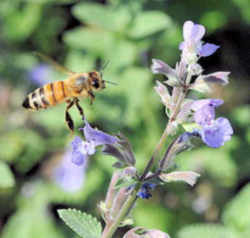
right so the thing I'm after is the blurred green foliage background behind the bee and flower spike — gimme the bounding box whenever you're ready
[0,0,250,238]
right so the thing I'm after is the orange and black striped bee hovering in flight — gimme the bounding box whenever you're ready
[22,53,112,132]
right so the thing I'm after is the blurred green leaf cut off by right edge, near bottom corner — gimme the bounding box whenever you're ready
[222,184,250,231]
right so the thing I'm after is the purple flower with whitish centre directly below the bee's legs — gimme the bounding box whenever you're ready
[72,120,118,165]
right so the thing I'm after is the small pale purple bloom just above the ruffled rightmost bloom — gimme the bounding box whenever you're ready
[191,99,223,126]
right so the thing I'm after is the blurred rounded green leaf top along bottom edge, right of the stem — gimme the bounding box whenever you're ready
[177,224,237,238]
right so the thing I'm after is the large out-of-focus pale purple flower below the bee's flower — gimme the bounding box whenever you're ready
[52,150,87,192]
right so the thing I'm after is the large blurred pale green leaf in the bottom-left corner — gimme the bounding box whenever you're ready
[1,187,64,238]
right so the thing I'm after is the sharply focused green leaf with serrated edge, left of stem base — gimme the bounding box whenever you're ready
[58,209,102,238]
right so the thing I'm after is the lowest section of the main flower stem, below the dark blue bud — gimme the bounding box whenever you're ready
[101,184,140,238]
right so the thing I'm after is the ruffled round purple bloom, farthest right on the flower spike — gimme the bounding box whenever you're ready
[200,117,233,148]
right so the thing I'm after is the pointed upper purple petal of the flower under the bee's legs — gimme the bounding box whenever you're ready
[80,120,118,146]
